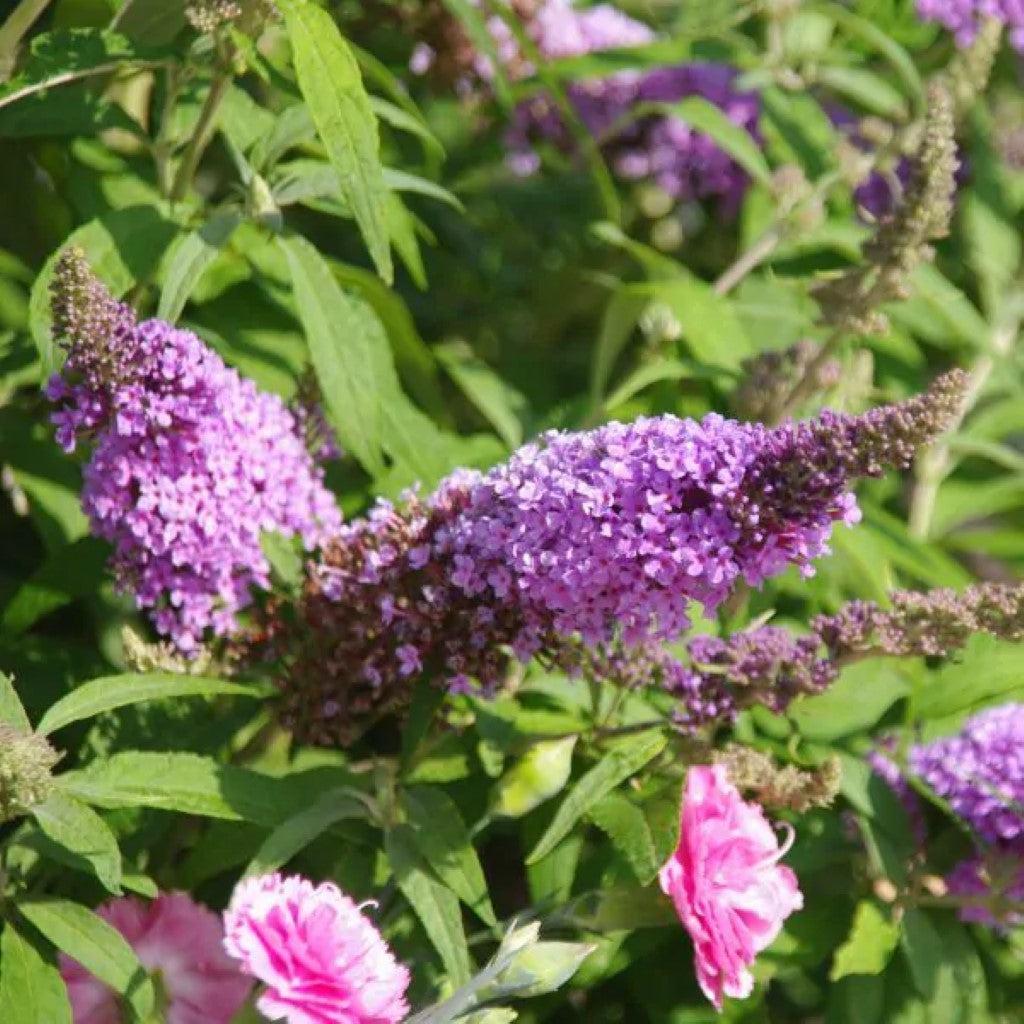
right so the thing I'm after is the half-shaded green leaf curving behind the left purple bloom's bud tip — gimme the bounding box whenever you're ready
[29,206,176,371]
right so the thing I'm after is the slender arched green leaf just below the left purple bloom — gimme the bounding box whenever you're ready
[38,672,262,736]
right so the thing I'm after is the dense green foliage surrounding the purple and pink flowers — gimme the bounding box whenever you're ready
[0,0,1024,1024]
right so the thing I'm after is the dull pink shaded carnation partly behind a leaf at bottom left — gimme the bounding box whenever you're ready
[60,893,252,1024]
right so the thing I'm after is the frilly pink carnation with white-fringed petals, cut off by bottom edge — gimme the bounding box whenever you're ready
[224,874,409,1024]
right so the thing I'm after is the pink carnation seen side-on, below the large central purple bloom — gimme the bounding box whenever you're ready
[658,765,804,1010]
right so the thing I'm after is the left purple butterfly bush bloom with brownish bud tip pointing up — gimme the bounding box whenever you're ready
[47,250,341,651]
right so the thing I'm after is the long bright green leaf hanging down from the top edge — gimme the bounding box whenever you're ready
[285,0,392,282]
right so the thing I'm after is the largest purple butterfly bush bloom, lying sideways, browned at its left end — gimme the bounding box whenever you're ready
[284,372,964,741]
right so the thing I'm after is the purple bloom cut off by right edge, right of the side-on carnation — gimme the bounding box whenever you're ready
[908,703,1024,851]
